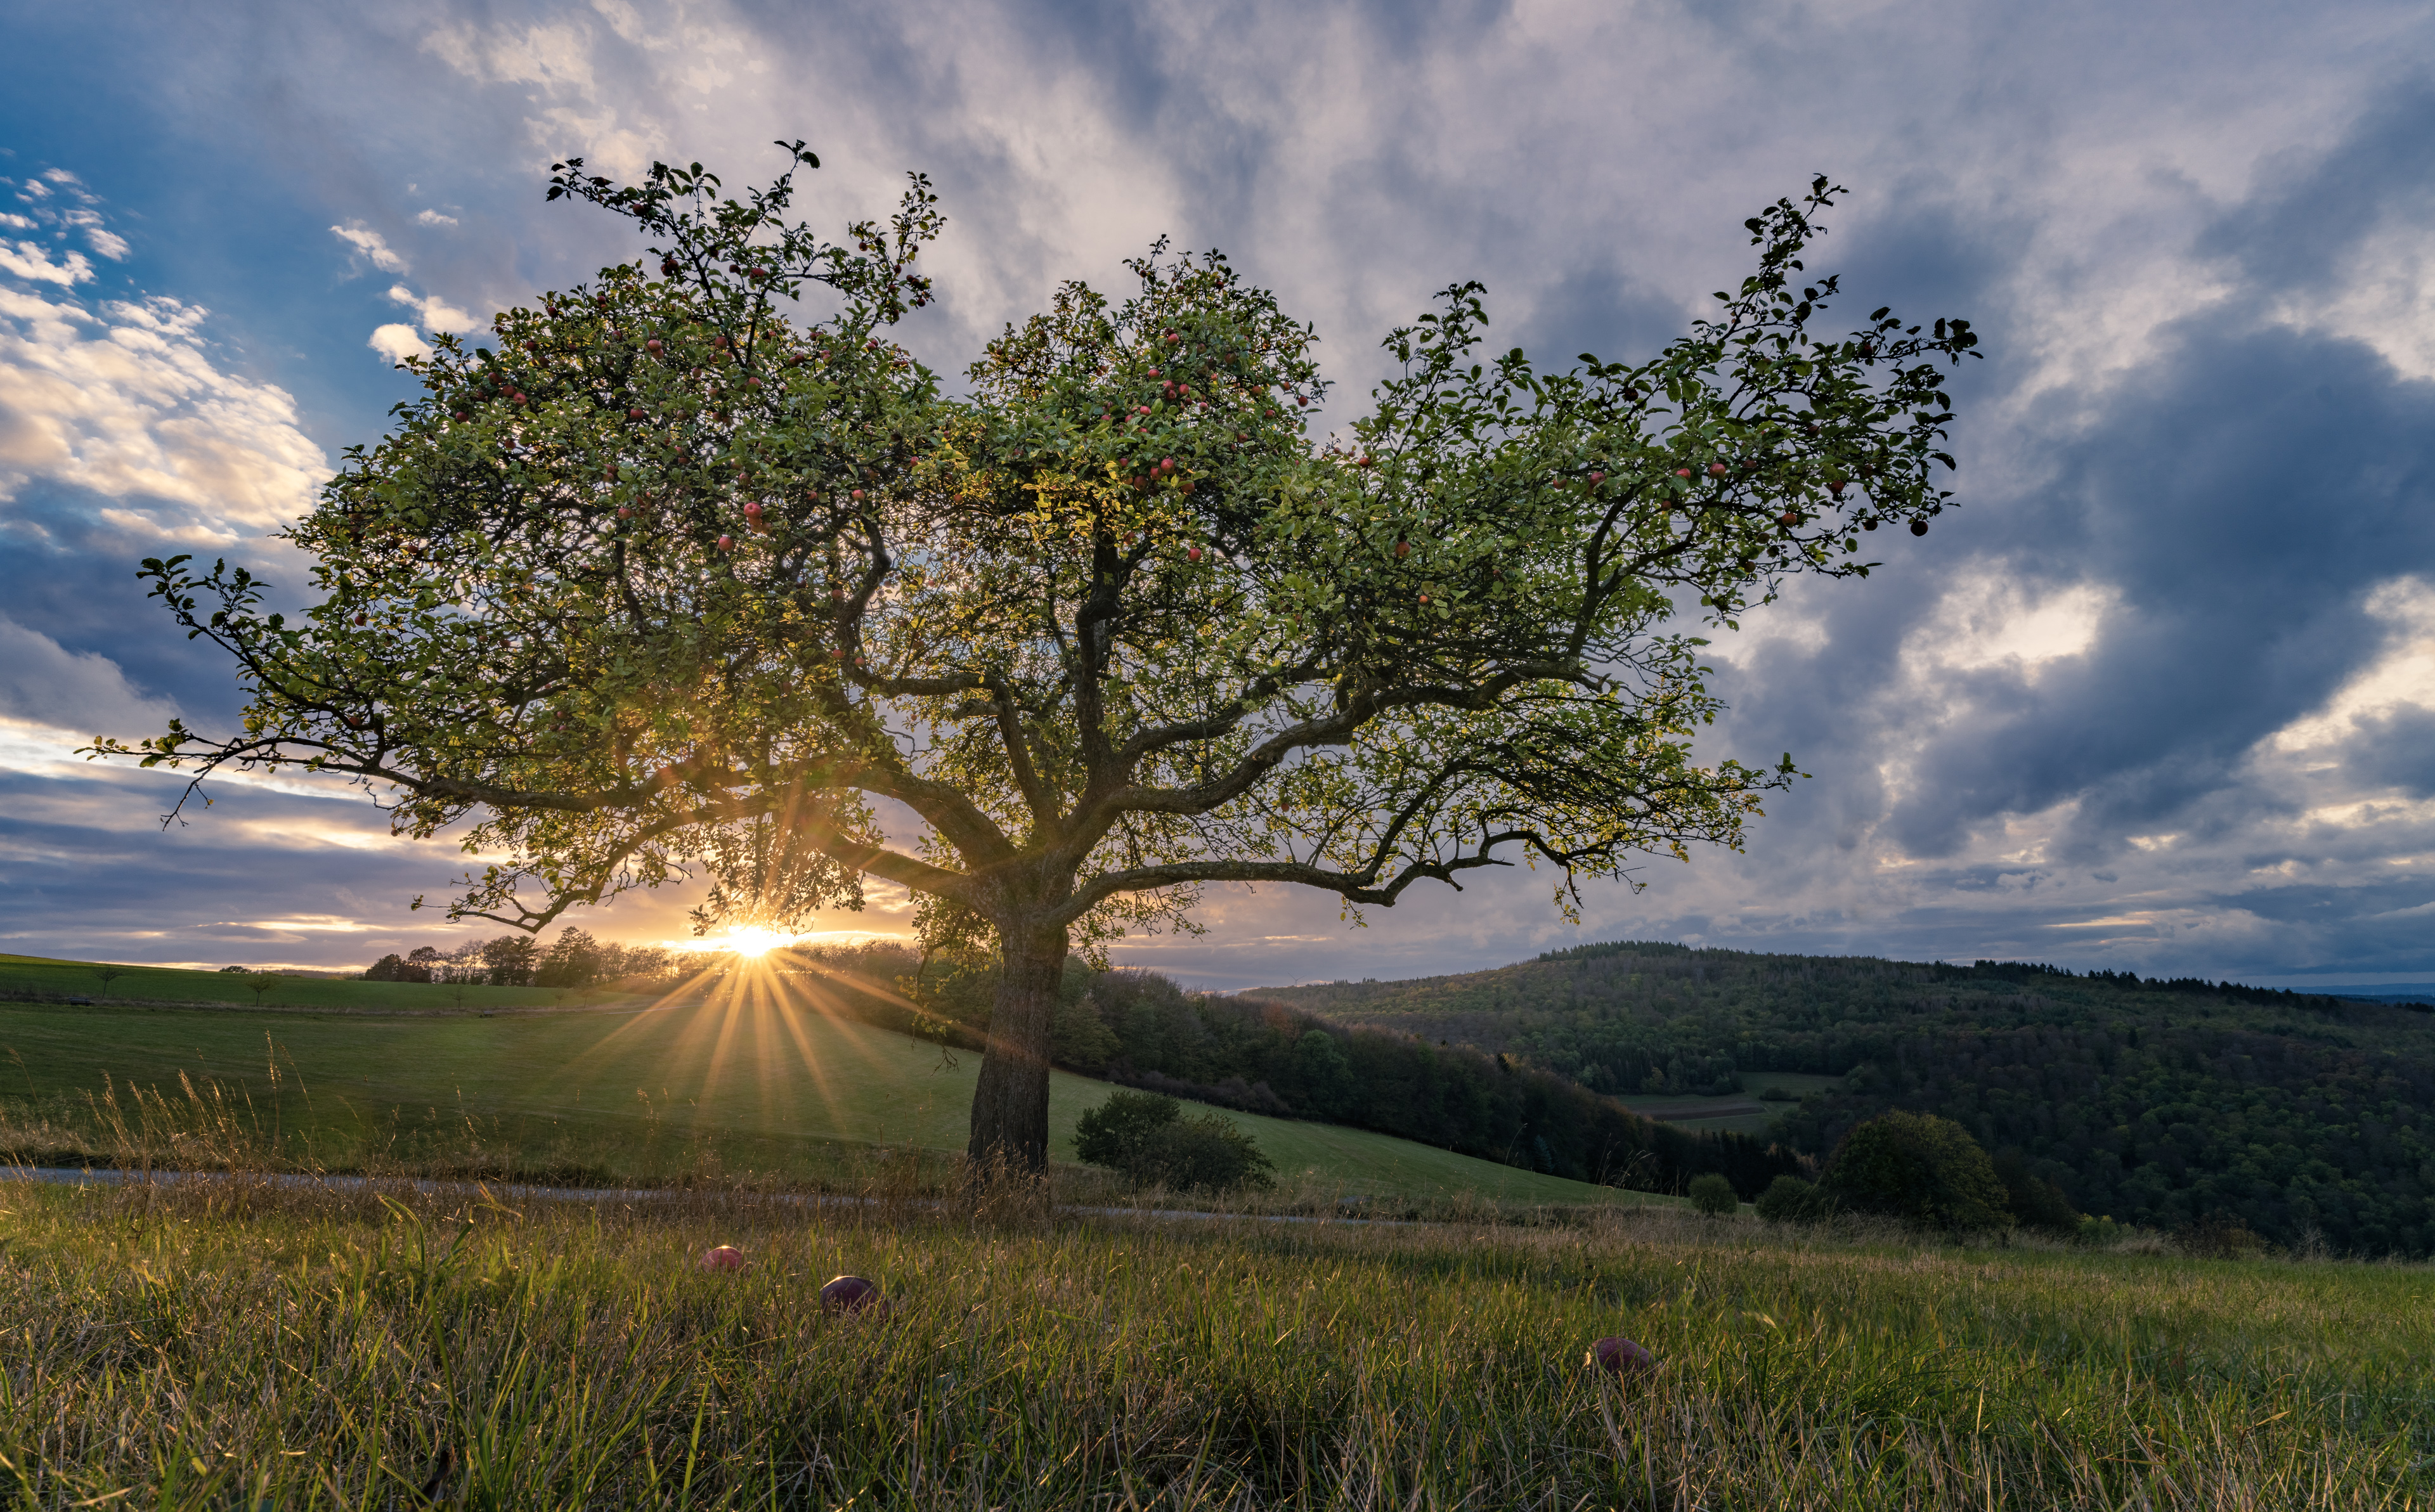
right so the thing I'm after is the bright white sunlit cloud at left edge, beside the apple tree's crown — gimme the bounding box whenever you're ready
[0,287,328,545]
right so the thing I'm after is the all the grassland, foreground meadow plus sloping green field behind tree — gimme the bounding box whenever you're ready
[0,964,2435,1512]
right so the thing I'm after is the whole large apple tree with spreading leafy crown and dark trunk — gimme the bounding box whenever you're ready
[98,144,1975,1168]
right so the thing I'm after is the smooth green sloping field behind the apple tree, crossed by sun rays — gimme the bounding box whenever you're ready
[0,976,1644,1203]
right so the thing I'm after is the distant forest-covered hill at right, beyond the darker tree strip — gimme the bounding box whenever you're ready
[1237,942,2435,1257]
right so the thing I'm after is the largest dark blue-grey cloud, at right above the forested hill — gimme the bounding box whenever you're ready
[1897,316,2435,860]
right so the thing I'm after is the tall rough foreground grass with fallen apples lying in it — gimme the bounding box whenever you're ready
[0,1186,2435,1512]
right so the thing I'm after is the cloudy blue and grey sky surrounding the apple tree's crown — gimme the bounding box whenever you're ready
[0,0,2435,988]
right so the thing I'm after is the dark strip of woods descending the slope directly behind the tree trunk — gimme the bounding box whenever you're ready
[772,947,1804,1198]
